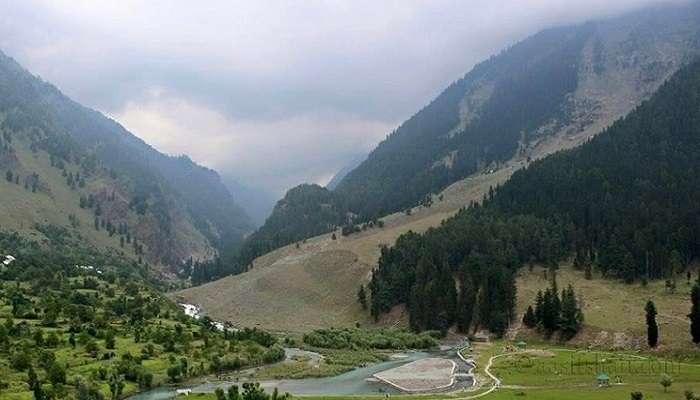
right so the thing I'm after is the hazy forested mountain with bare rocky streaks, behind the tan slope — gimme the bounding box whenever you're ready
[231,2,700,272]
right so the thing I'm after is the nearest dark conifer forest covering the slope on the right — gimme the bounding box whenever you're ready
[370,57,700,333]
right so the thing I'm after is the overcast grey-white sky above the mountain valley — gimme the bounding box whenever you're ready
[0,0,684,195]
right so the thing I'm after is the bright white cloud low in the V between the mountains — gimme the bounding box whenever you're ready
[112,91,396,196]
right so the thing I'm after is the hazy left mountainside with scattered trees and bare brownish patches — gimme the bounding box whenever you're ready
[0,53,252,267]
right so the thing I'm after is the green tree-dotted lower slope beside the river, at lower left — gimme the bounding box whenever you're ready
[0,231,284,399]
